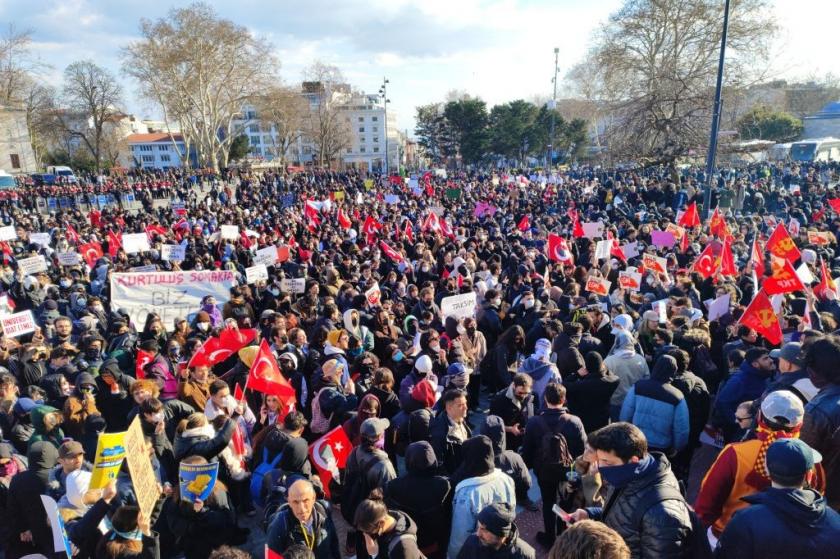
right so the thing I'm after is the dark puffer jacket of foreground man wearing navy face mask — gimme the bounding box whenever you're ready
[587,452,691,559]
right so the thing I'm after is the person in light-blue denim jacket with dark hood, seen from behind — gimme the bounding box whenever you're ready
[448,436,516,558]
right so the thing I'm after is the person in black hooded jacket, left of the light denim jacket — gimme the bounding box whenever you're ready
[384,441,452,557]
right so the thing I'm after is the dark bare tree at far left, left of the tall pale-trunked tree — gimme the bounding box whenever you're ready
[57,60,122,170]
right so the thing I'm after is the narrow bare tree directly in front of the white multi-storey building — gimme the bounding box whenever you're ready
[303,61,351,166]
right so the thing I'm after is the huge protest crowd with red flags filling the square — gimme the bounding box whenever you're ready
[0,162,840,559]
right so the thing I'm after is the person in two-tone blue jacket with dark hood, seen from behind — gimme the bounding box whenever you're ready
[620,355,691,451]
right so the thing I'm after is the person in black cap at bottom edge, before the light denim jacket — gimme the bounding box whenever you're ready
[458,503,536,559]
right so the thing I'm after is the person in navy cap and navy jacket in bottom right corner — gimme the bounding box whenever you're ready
[715,439,840,559]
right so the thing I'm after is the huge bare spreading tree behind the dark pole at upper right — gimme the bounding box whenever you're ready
[570,0,776,164]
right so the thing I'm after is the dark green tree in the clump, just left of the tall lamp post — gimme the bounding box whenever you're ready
[489,99,539,162]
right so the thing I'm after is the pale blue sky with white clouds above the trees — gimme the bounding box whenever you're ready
[6,0,840,133]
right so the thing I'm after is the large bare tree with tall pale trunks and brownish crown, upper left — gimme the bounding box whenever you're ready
[123,3,279,169]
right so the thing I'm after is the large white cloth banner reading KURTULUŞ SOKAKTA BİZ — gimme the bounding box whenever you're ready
[111,270,236,330]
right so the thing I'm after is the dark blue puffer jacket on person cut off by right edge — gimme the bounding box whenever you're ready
[800,384,840,510]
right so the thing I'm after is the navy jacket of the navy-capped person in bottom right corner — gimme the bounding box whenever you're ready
[715,487,840,559]
